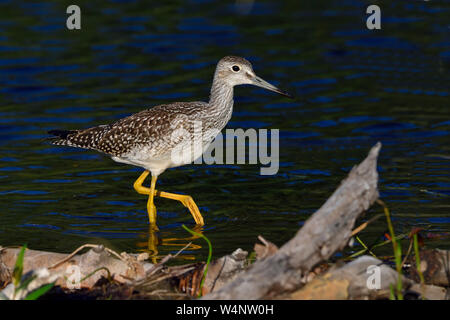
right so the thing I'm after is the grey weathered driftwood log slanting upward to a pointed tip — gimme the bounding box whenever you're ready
[204,143,381,299]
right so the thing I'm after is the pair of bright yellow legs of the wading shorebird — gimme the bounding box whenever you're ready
[133,170,205,225]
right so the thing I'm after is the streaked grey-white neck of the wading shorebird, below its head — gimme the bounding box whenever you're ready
[208,74,233,127]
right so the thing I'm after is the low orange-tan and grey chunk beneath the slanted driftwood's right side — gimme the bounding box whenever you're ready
[285,256,412,300]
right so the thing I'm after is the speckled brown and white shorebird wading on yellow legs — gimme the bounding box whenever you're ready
[48,56,291,226]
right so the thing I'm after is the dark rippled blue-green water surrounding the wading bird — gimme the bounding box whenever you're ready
[0,1,450,260]
